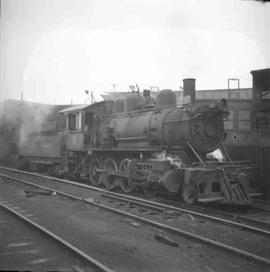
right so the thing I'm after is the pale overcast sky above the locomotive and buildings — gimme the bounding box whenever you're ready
[0,0,270,104]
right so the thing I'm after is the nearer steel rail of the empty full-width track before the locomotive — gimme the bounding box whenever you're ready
[1,174,270,266]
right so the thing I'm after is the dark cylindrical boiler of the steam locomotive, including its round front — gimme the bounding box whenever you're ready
[110,93,225,153]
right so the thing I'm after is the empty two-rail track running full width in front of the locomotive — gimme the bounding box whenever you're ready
[0,167,270,266]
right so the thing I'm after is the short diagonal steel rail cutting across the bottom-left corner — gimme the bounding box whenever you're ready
[0,202,113,272]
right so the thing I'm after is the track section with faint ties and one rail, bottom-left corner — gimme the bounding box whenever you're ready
[0,199,112,272]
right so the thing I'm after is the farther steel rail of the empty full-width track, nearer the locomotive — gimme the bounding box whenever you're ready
[0,166,270,236]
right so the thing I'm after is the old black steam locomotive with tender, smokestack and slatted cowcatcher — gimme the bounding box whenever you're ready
[19,79,256,204]
